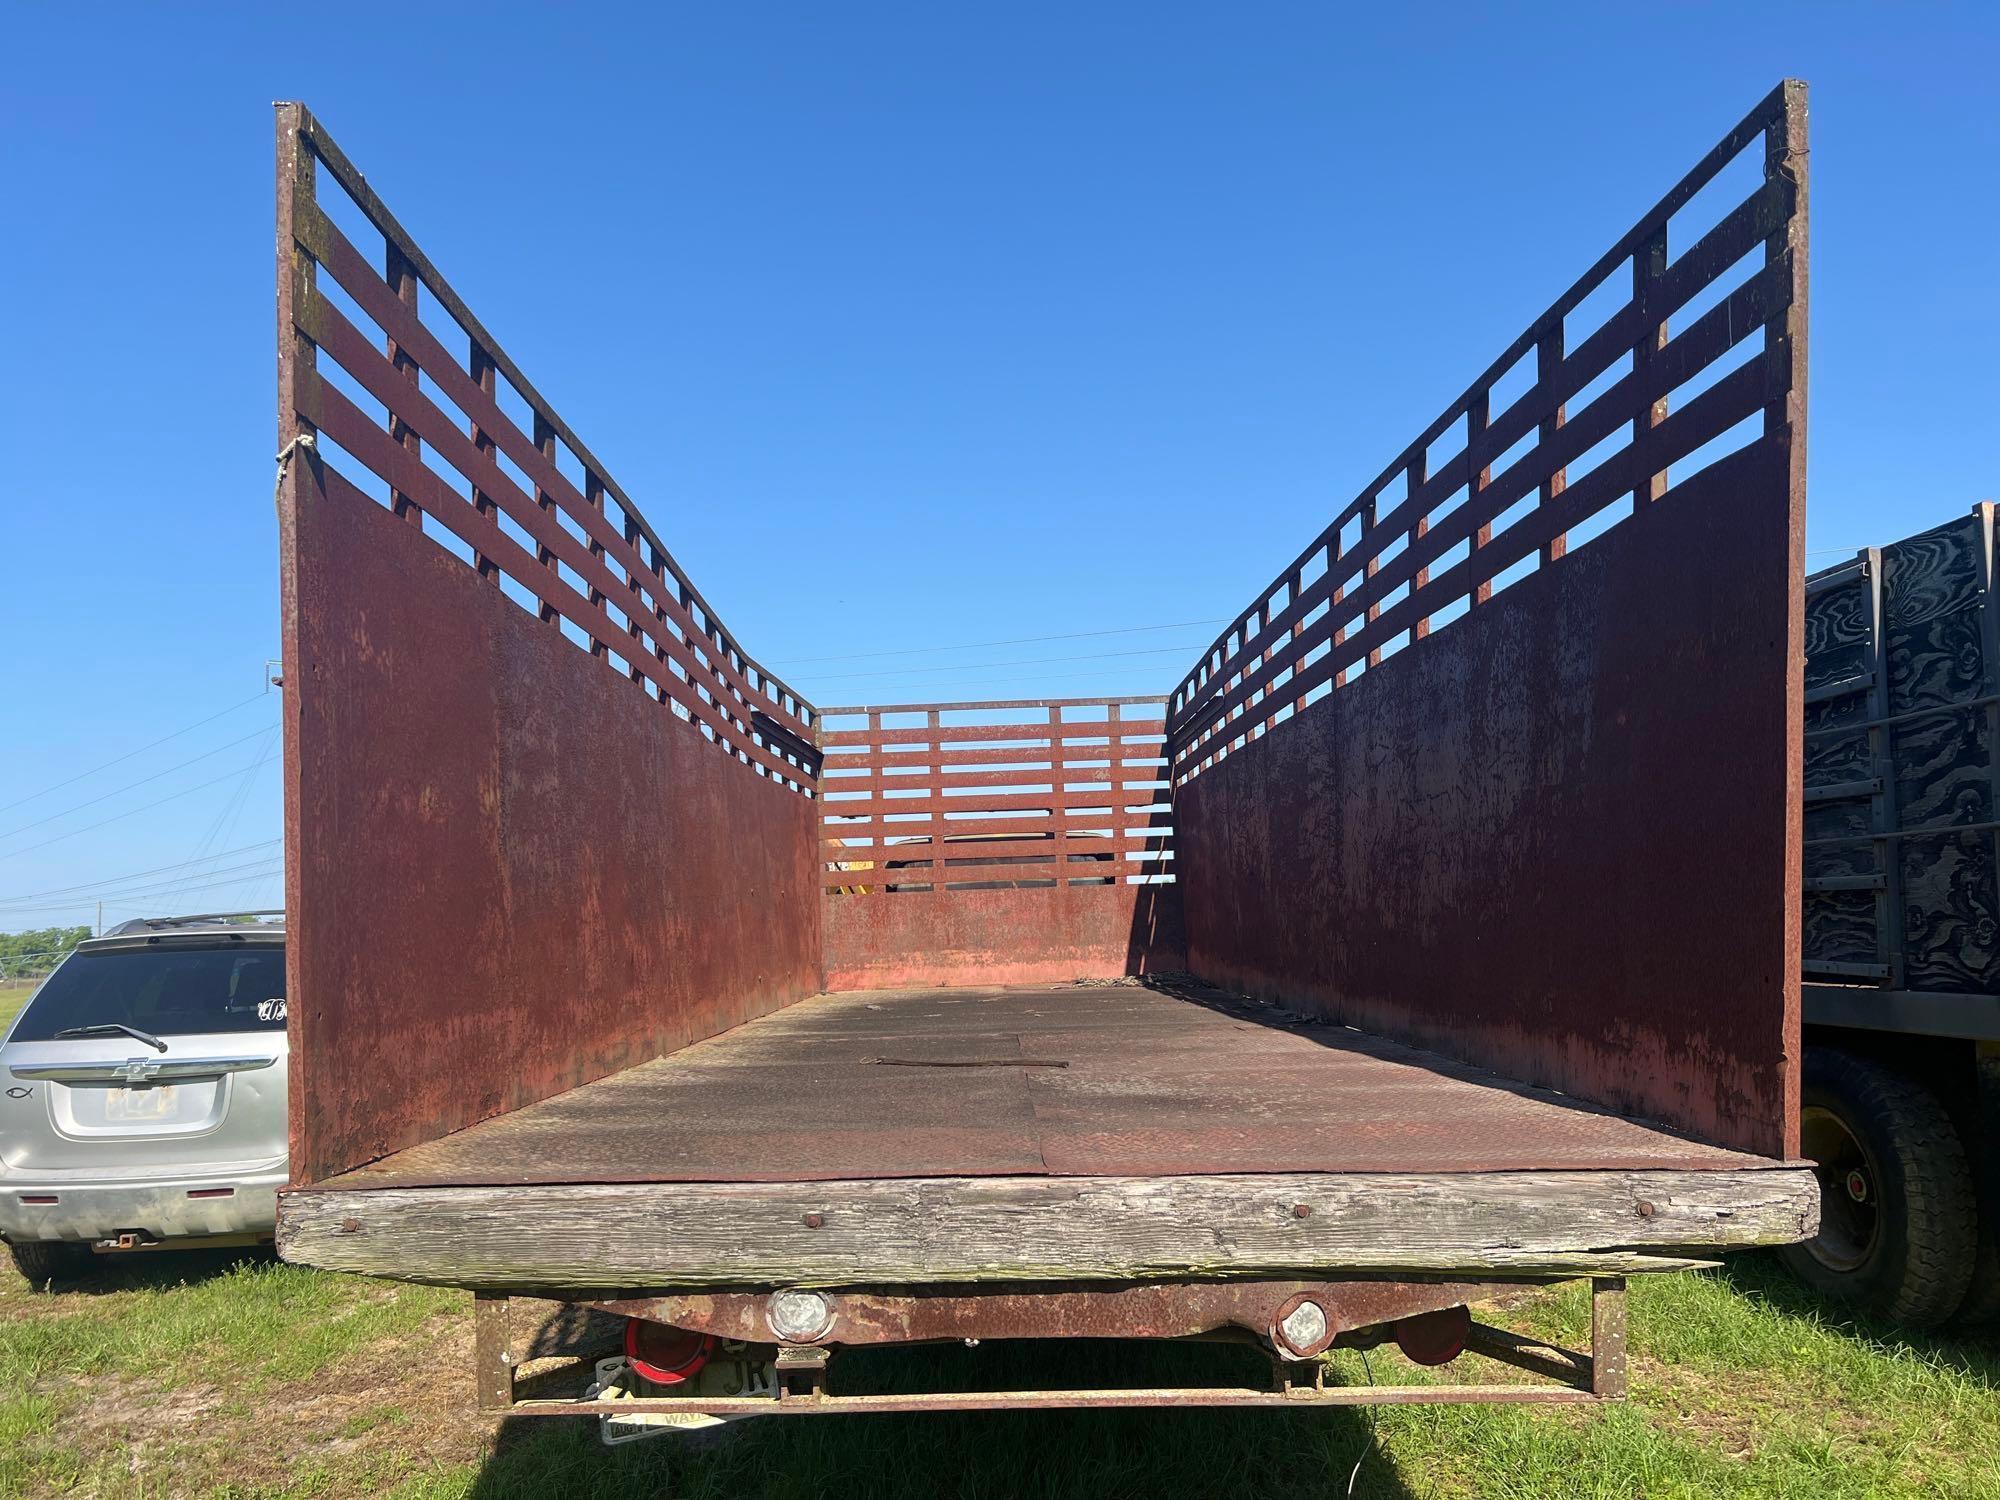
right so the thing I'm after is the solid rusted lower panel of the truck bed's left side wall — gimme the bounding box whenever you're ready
[286,474,820,1182]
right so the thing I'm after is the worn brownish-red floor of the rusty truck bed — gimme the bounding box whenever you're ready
[320,984,1772,1190]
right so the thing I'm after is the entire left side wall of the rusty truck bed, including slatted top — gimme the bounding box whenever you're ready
[278,104,820,1182]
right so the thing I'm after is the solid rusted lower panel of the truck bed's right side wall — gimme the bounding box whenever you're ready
[1174,442,1798,1156]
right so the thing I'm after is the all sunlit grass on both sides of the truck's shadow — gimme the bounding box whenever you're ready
[0,1256,2000,1500]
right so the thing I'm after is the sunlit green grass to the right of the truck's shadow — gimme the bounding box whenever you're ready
[1340,1256,2000,1500]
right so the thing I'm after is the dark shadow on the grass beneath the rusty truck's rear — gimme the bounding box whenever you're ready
[472,1344,1412,1500]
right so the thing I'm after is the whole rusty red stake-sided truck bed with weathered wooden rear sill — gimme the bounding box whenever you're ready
[278,82,1818,1424]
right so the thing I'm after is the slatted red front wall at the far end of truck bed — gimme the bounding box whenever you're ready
[820,698,1186,990]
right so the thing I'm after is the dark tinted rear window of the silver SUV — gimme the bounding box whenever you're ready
[12,944,284,1042]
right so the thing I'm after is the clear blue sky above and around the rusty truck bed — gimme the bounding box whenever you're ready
[0,4,2000,930]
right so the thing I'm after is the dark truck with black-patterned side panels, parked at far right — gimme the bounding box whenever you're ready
[1786,504,2000,1326]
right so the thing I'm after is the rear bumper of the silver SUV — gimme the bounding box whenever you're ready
[0,1168,286,1244]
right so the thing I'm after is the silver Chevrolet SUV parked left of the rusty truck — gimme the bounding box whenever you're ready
[0,918,286,1284]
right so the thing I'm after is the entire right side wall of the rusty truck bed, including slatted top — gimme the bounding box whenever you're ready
[1168,84,1806,1156]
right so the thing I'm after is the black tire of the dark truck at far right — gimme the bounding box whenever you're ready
[1780,1046,1978,1328]
